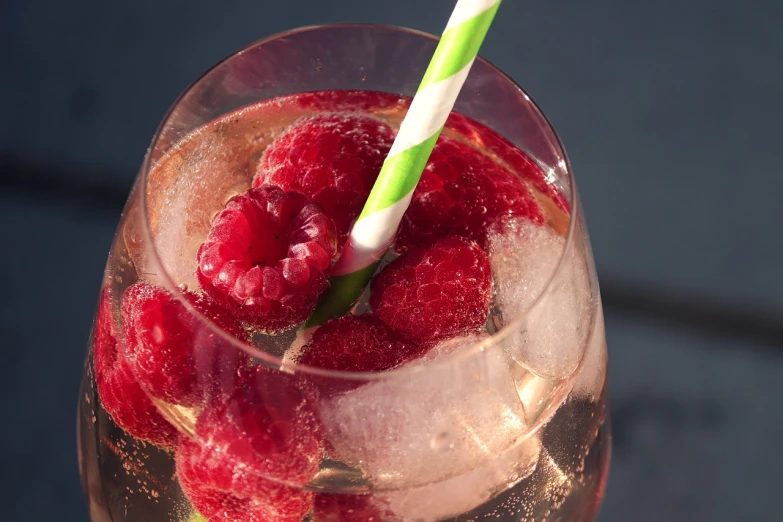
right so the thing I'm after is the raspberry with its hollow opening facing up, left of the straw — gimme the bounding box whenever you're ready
[197,186,337,332]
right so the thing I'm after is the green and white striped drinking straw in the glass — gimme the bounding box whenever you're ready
[305,0,501,328]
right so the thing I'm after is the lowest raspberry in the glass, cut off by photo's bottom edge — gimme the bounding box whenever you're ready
[176,437,313,522]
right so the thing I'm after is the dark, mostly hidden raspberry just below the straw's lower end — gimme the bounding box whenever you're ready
[299,314,422,372]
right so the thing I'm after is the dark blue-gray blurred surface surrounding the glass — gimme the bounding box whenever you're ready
[0,0,783,522]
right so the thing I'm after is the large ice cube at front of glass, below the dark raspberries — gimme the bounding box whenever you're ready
[321,335,528,489]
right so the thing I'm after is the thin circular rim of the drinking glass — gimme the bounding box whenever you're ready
[139,23,580,382]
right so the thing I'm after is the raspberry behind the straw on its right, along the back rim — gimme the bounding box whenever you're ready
[395,137,544,252]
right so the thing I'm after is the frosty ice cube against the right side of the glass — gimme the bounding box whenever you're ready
[490,221,593,379]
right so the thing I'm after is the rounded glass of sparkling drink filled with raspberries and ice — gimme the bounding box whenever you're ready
[78,26,610,521]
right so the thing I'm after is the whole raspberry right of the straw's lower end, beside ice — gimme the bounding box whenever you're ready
[370,236,492,343]
